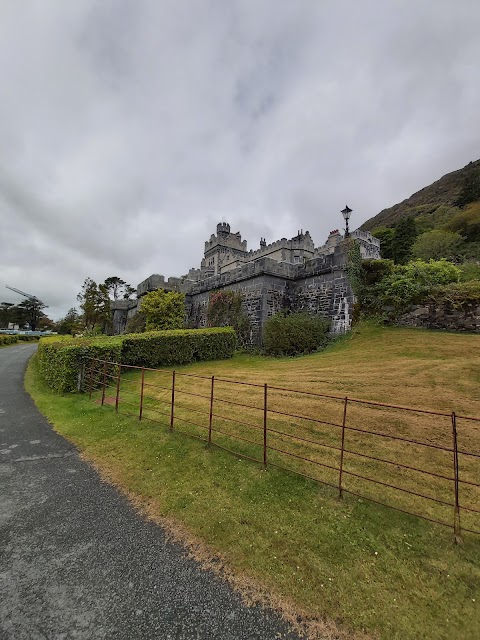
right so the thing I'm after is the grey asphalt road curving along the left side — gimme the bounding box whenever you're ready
[0,345,298,640]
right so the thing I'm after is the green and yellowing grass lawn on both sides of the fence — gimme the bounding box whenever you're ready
[26,325,480,640]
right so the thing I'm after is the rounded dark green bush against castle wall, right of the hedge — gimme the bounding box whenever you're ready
[263,313,330,356]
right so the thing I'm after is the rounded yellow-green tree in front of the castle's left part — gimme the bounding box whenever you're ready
[140,289,185,331]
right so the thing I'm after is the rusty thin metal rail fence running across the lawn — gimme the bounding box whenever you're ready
[83,359,480,541]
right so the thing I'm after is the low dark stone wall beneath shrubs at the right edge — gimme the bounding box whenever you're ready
[395,302,480,333]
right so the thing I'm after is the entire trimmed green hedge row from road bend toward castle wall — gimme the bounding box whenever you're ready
[38,327,236,393]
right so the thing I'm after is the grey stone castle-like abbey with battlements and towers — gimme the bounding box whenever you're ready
[113,222,380,344]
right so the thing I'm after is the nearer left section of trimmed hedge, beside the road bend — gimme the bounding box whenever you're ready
[37,338,122,393]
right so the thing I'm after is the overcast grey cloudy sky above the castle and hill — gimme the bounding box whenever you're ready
[0,0,480,319]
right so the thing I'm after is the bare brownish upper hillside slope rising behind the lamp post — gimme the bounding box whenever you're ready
[360,160,480,231]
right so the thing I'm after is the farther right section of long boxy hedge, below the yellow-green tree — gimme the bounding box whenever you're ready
[122,327,236,368]
